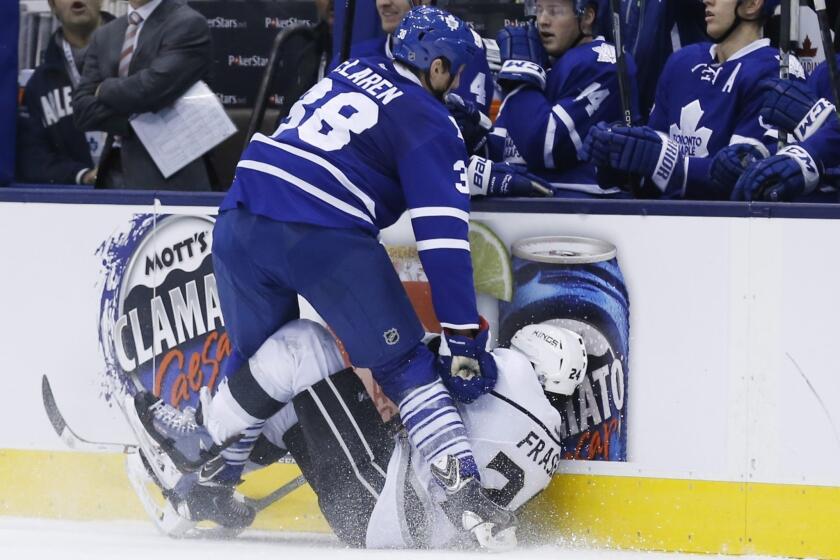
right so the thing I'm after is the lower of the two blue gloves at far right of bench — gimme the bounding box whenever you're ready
[732,145,822,202]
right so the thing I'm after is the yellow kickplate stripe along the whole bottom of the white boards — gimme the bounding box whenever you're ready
[0,450,840,560]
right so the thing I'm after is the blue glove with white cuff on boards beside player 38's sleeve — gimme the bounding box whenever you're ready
[467,156,553,196]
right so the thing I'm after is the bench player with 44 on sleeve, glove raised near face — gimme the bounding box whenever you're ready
[488,0,637,197]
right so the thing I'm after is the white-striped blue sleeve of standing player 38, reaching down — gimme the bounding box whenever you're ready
[397,116,478,329]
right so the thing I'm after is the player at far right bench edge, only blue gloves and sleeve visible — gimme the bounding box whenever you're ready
[728,75,840,202]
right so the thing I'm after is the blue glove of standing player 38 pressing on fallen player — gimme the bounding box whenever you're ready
[437,317,498,403]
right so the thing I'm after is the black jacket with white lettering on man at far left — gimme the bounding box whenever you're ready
[17,12,114,184]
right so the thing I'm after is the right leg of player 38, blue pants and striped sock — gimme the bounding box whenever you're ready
[288,224,516,546]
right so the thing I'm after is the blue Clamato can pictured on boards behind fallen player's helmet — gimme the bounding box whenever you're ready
[499,237,630,461]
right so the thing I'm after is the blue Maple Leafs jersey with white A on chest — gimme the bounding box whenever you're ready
[648,39,805,200]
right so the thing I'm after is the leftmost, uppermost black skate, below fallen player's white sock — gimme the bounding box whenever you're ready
[125,391,222,472]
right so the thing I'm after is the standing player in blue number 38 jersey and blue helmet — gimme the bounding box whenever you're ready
[125,7,515,548]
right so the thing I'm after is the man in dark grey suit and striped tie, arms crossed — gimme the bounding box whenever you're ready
[73,0,212,190]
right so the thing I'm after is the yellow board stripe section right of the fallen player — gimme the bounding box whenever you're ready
[523,475,840,559]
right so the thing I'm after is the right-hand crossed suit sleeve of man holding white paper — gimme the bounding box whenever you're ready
[96,12,212,115]
